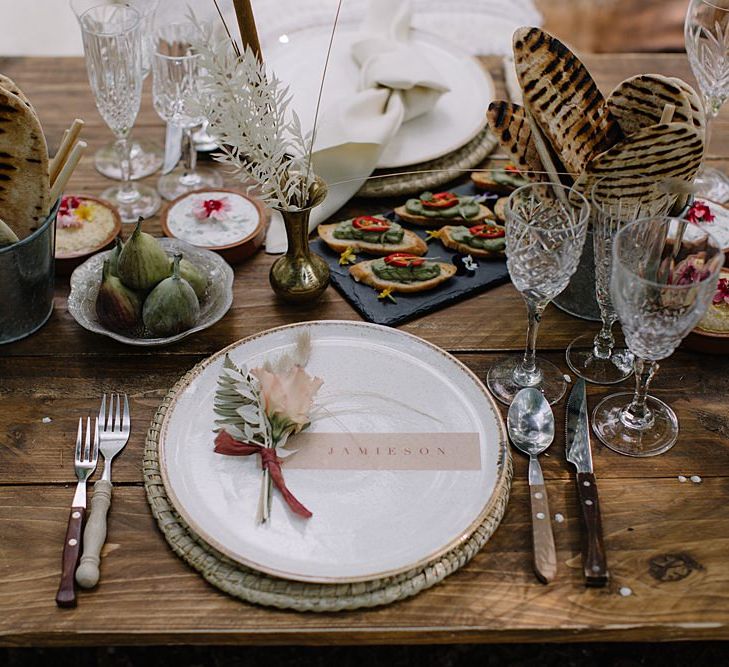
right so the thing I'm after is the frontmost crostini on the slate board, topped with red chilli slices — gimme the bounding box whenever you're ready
[349,252,456,292]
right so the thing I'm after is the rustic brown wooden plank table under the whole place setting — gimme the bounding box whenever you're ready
[0,55,729,646]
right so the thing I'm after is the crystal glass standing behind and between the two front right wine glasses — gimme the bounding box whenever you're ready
[566,178,676,384]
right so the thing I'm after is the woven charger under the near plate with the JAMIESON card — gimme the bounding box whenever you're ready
[143,369,512,612]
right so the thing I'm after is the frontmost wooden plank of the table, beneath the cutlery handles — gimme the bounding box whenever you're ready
[0,478,729,644]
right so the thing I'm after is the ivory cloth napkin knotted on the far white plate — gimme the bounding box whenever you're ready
[266,0,448,253]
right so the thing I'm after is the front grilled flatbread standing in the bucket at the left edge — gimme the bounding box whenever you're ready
[0,85,49,239]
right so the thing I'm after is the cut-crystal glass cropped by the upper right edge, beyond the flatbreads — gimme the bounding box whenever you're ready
[684,0,729,202]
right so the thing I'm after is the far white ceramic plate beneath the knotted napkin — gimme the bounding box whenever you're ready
[265,26,495,168]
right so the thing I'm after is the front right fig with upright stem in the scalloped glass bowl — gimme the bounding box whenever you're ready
[142,254,200,337]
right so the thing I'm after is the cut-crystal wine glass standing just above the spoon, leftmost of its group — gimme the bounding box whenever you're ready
[486,183,590,404]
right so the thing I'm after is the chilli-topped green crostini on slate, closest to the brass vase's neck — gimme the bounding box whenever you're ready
[318,215,428,255]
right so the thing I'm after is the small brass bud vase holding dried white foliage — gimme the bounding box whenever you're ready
[268,178,329,303]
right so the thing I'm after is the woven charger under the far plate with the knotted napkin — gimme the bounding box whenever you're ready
[357,127,498,197]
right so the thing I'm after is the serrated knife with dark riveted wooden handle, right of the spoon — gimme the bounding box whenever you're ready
[565,378,610,587]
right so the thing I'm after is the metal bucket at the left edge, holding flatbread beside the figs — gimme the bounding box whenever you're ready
[0,199,60,344]
